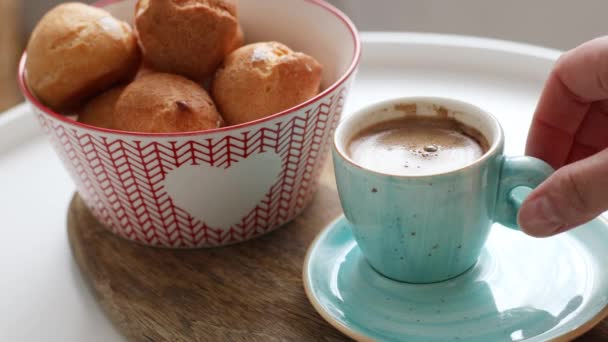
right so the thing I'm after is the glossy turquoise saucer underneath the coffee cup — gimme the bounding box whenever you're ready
[304,217,608,342]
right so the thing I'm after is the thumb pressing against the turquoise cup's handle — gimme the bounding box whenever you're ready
[518,149,608,237]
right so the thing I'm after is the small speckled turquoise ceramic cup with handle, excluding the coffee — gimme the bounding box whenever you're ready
[333,97,553,283]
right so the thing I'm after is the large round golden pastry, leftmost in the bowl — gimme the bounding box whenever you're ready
[26,3,140,110]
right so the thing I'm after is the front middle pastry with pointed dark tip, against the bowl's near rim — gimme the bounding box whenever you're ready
[114,73,223,133]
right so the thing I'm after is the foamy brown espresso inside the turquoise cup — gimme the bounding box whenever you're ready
[347,116,489,176]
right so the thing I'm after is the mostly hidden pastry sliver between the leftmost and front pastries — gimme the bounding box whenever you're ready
[78,85,125,129]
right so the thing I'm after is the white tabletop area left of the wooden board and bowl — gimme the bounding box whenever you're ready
[0,104,123,342]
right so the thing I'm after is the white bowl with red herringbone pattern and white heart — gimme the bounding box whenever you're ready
[19,0,361,248]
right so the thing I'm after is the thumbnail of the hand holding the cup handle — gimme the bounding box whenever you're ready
[517,196,562,237]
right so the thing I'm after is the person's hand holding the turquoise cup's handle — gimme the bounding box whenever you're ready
[518,37,608,237]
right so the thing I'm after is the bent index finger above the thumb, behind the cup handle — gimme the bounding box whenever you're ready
[526,37,608,168]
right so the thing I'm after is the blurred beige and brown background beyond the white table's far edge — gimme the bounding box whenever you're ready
[0,0,608,112]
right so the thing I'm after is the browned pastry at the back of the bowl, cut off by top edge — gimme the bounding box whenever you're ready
[135,0,239,81]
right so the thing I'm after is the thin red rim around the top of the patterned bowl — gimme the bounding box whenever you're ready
[18,0,361,137]
